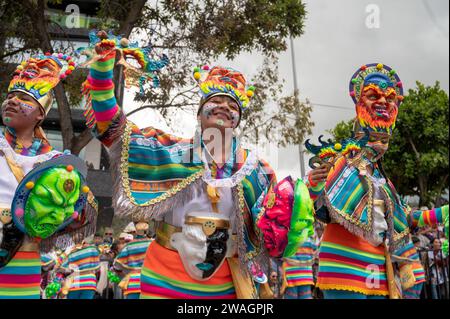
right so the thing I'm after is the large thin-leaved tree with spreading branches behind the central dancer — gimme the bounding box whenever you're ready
[0,0,313,153]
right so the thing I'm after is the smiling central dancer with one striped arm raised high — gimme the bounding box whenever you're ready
[80,32,312,299]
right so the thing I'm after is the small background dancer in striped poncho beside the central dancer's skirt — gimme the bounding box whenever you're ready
[113,221,152,299]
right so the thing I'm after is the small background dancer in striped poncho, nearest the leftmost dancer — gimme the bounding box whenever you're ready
[61,238,100,299]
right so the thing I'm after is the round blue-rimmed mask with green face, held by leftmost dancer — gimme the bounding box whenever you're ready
[11,155,89,239]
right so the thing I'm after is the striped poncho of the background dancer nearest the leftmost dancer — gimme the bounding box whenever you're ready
[61,246,100,291]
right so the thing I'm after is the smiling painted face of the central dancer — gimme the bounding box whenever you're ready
[200,96,240,129]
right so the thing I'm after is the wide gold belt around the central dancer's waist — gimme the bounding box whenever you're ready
[155,220,236,251]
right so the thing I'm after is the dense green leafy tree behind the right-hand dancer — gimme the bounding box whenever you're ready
[330,82,449,207]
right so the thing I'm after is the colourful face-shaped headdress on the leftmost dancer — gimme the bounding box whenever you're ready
[8,53,75,115]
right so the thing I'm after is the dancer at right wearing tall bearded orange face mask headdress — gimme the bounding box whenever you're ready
[306,64,448,299]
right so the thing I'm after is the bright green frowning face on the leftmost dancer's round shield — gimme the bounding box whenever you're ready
[24,168,81,238]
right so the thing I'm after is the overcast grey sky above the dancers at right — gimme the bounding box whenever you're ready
[127,0,449,178]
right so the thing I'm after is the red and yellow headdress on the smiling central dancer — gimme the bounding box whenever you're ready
[194,66,255,112]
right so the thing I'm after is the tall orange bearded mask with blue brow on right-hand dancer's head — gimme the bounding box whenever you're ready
[350,63,403,135]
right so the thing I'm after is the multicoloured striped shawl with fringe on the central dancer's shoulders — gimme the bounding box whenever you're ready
[110,122,275,272]
